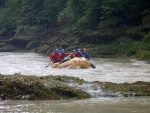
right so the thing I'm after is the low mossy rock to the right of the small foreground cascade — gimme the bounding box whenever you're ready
[95,81,150,97]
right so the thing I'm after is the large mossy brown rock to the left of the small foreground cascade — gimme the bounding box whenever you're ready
[0,75,90,100]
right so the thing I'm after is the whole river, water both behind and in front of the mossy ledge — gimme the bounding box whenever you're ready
[0,52,150,113]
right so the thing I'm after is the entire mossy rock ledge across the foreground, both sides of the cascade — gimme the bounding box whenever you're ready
[0,73,150,100]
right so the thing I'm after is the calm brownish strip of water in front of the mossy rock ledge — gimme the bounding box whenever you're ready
[0,97,150,113]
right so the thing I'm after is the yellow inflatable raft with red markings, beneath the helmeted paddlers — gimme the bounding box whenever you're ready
[51,57,90,69]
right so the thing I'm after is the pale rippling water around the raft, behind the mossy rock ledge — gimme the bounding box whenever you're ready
[0,52,150,83]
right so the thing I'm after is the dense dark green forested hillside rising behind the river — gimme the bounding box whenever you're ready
[0,0,150,59]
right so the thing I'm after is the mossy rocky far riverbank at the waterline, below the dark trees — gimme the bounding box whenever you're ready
[0,37,150,62]
